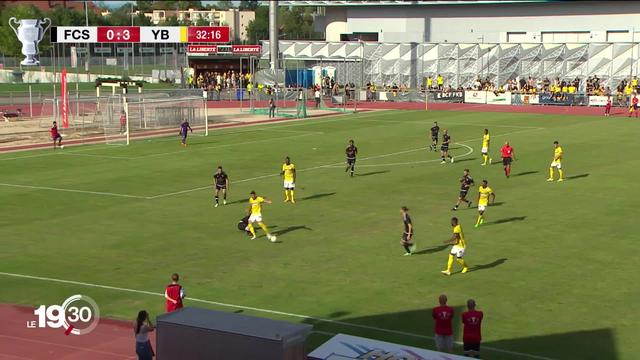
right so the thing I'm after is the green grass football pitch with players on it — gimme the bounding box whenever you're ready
[0,111,640,360]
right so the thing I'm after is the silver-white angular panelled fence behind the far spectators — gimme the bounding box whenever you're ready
[262,41,640,91]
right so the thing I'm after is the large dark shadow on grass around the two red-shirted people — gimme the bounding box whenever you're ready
[303,310,620,360]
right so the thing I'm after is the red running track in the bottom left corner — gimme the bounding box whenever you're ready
[0,304,146,360]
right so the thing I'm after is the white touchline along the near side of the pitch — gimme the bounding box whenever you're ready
[0,271,553,360]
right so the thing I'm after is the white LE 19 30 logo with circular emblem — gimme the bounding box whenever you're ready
[27,295,100,335]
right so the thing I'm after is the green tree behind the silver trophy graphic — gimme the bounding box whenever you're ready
[0,5,43,57]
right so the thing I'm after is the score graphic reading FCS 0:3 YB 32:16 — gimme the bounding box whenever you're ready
[50,26,231,44]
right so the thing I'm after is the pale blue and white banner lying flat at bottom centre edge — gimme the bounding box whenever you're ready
[307,334,468,360]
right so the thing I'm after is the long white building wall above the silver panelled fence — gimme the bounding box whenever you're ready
[325,1,640,43]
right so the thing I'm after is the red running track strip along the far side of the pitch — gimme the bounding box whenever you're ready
[0,101,627,152]
